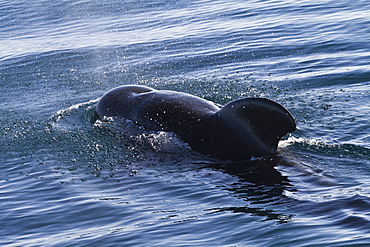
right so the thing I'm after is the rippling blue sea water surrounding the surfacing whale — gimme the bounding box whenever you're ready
[0,0,370,246]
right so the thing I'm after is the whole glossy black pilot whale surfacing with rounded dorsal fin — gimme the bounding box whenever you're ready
[95,85,296,161]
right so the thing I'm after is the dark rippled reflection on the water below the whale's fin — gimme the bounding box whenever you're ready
[202,156,296,224]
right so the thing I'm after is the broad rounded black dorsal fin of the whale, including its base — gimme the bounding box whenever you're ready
[212,98,296,160]
